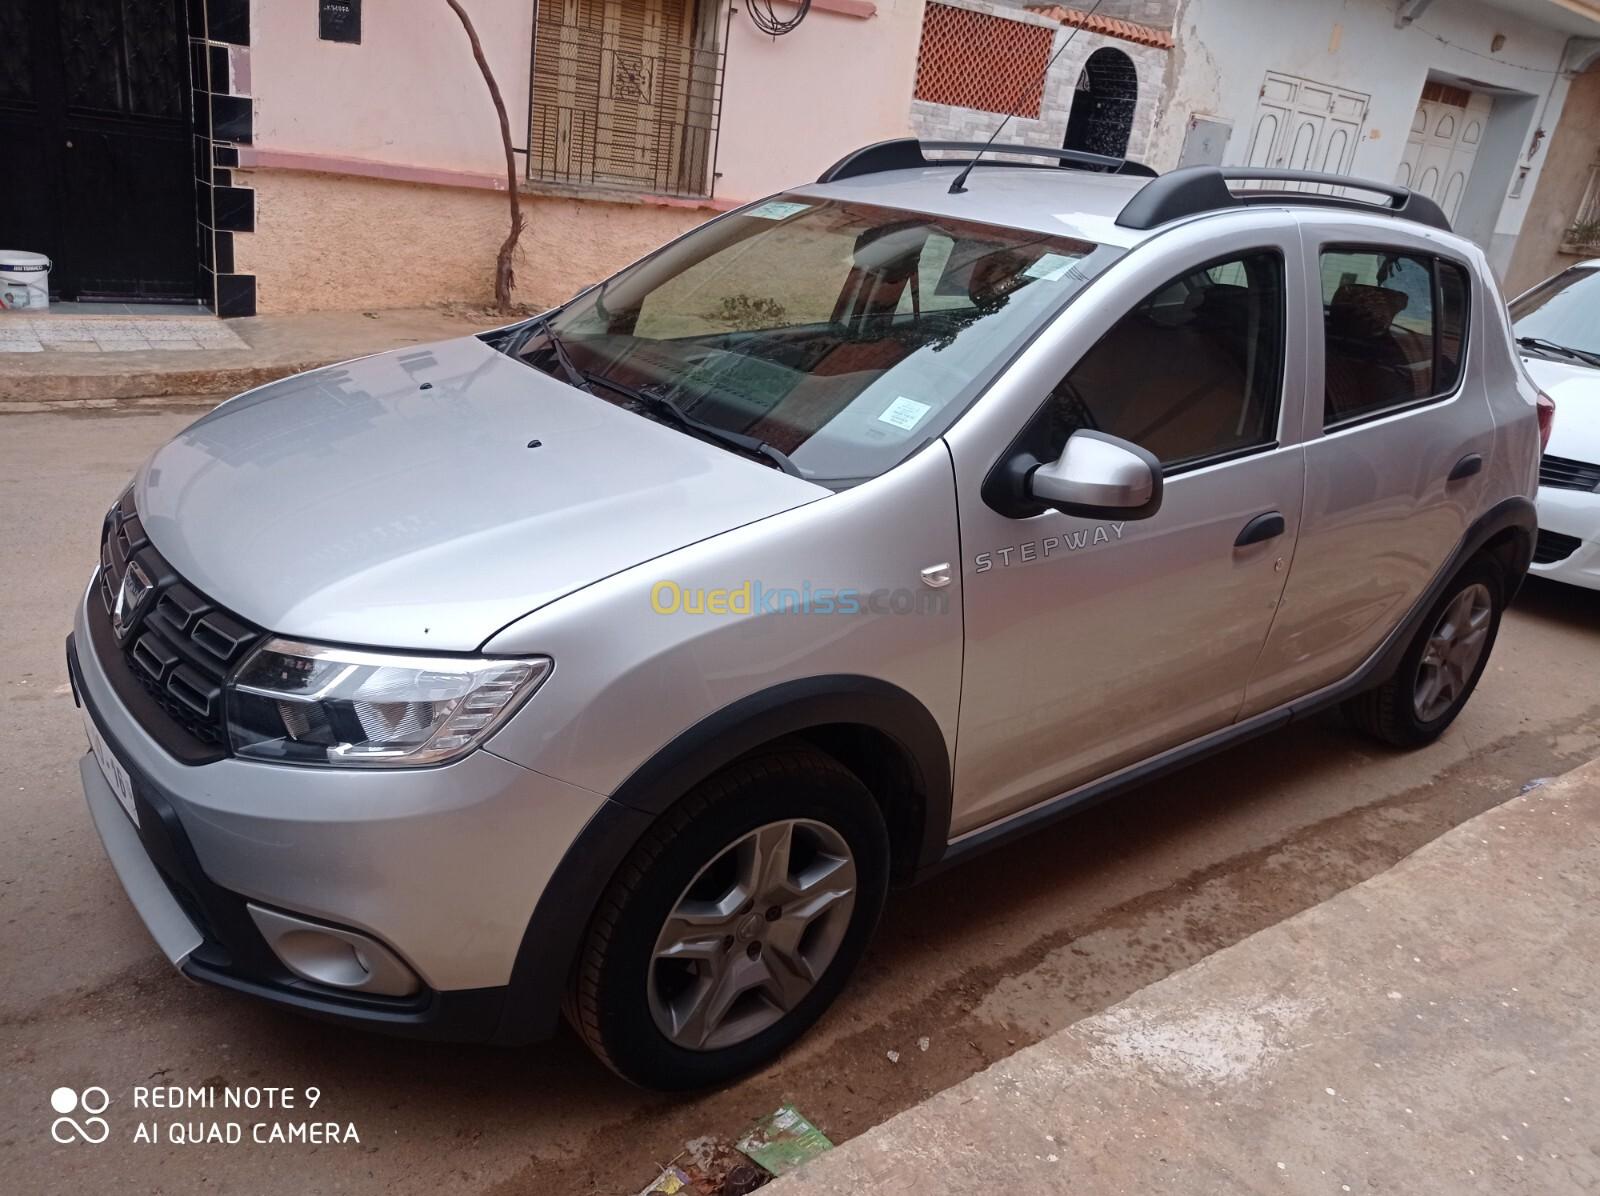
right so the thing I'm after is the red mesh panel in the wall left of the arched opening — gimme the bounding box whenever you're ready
[915,5,1056,118]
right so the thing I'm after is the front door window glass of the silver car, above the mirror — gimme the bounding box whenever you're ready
[1043,251,1283,472]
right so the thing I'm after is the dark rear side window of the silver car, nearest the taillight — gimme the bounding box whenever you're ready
[1322,246,1470,427]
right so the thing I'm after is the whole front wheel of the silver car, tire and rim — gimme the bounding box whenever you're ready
[566,747,890,1089]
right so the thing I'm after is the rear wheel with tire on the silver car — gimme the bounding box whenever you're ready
[1342,558,1506,748]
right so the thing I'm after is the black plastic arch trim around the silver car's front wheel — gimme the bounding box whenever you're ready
[496,673,952,1043]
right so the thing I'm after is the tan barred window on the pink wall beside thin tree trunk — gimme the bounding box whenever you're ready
[528,0,730,195]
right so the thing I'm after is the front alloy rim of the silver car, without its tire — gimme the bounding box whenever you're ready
[648,819,856,1050]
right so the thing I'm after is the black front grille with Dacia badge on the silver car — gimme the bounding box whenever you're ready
[99,491,262,748]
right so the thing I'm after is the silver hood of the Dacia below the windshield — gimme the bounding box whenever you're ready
[134,337,829,651]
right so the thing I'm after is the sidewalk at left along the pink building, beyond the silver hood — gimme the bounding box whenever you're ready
[0,309,505,411]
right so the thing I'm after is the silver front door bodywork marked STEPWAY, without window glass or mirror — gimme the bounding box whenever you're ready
[946,213,1306,835]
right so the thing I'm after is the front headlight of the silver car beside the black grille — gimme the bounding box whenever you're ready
[227,640,552,767]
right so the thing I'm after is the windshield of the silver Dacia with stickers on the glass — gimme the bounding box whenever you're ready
[507,195,1122,486]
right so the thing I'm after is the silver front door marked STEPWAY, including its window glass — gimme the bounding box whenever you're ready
[949,214,1304,836]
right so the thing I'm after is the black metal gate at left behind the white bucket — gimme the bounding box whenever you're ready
[0,0,198,299]
